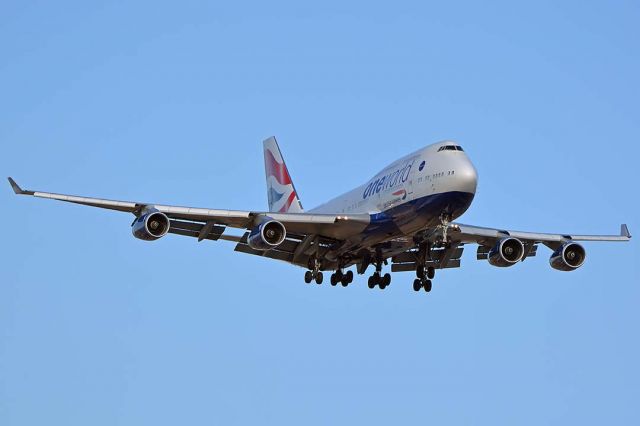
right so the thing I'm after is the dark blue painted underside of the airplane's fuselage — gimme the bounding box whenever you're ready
[362,191,475,243]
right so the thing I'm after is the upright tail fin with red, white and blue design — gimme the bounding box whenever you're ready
[263,136,304,213]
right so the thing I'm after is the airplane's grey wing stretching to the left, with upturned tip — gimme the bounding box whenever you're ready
[9,178,370,265]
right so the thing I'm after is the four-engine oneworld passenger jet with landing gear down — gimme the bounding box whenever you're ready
[8,137,631,292]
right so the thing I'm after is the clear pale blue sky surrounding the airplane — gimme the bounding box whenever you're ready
[0,1,640,426]
